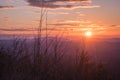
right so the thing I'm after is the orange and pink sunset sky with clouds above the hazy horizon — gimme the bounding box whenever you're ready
[0,0,120,36]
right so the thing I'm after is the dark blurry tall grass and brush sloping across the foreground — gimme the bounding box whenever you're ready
[0,39,119,80]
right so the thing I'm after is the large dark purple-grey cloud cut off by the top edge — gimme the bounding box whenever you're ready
[26,0,99,9]
